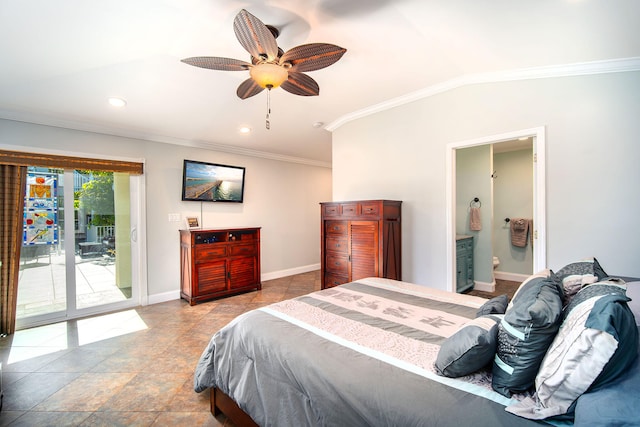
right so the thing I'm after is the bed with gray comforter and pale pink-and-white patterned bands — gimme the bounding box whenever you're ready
[194,270,640,427]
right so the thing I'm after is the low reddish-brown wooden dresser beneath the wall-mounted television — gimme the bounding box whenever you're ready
[180,228,262,305]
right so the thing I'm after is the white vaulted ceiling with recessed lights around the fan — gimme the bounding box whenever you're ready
[0,0,640,164]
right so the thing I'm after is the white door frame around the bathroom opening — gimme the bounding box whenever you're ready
[445,126,547,292]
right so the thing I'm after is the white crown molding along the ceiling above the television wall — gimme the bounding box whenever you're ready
[0,110,331,169]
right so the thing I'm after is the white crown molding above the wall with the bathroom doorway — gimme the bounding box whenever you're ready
[325,57,640,132]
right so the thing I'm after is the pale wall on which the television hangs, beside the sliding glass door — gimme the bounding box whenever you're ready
[0,119,331,301]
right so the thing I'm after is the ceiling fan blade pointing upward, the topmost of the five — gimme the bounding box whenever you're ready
[233,9,278,61]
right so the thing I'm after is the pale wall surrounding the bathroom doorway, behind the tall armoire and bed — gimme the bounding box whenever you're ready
[333,72,640,289]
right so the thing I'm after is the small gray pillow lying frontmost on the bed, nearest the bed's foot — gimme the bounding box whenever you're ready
[435,315,502,378]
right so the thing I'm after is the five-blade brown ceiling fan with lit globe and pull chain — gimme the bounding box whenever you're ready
[182,9,347,129]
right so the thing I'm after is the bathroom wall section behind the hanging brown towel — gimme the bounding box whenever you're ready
[493,149,533,278]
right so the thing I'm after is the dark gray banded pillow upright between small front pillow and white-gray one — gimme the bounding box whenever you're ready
[491,274,562,397]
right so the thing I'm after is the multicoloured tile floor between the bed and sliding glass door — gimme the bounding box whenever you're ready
[0,271,320,427]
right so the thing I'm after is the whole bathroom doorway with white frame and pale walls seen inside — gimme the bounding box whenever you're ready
[447,127,546,292]
